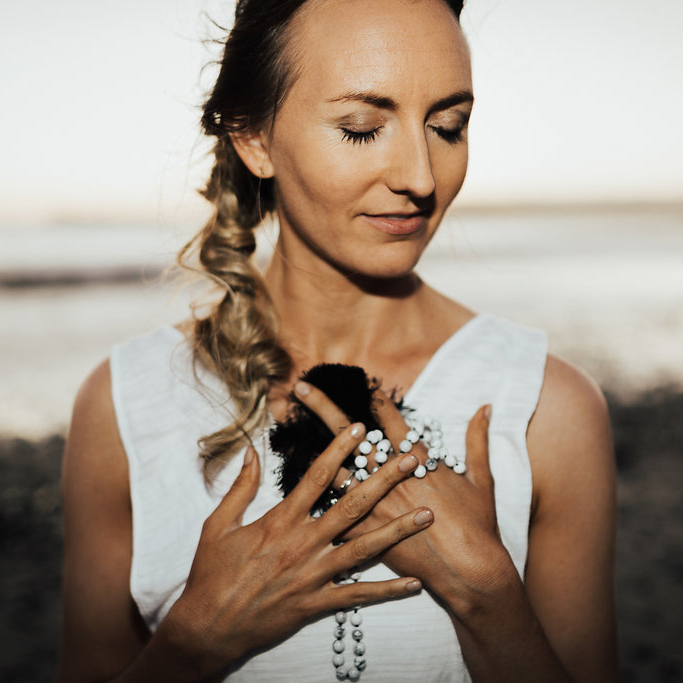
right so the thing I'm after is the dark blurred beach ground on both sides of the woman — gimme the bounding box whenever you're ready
[0,390,683,683]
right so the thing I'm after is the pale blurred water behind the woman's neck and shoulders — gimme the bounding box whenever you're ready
[0,207,683,438]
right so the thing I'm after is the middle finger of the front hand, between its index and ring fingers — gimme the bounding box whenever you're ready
[318,454,419,538]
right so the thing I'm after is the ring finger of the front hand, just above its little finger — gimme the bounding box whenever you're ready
[331,507,434,575]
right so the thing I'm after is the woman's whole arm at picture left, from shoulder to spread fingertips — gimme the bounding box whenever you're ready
[59,363,431,683]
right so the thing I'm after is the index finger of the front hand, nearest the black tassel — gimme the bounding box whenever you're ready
[282,422,365,514]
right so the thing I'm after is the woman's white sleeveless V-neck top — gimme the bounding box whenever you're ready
[111,314,547,683]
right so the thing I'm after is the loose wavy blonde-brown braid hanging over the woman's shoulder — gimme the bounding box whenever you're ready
[179,136,291,477]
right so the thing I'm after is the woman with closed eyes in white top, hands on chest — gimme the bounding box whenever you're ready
[61,0,616,682]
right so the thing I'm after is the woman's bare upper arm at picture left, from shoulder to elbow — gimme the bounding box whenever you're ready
[59,363,149,681]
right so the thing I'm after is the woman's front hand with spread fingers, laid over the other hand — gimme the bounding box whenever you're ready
[156,424,433,678]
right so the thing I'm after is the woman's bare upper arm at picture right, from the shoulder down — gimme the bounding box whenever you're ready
[526,357,618,682]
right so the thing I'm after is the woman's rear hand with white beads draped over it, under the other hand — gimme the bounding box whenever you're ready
[297,385,515,614]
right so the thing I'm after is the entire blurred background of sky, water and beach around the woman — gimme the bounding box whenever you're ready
[0,0,683,681]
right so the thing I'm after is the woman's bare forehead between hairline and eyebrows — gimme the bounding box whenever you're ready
[290,0,471,103]
